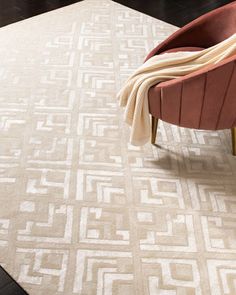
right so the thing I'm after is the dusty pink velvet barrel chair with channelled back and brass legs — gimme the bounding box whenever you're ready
[146,1,236,155]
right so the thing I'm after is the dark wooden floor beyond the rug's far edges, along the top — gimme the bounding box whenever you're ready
[0,0,233,27]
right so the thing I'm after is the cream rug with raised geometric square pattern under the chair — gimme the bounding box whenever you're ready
[0,0,236,295]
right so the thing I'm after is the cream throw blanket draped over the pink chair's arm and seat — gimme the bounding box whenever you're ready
[118,34,236,145]
